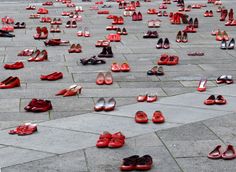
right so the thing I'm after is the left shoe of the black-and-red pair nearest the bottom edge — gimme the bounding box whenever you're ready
[120,155,139,171]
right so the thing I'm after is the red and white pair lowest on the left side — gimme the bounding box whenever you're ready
[9,123,38,136]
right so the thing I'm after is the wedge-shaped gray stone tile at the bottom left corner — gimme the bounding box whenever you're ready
[0,147,53,171]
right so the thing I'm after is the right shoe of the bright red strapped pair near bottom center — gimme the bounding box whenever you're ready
[108,132,125,148]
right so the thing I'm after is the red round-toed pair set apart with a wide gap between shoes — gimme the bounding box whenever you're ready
[135,111,165,123]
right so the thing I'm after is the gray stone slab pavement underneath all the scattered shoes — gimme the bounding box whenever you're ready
[0,0,236,172]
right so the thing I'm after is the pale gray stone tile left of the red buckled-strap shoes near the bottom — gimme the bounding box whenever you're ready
[0,126,97,154]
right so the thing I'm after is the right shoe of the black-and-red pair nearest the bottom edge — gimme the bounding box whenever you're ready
[135,155,153,170]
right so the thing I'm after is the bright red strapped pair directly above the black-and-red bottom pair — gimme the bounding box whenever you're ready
[96,131,125,148]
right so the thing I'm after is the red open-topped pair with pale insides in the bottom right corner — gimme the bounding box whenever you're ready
[208,145,236,160]
